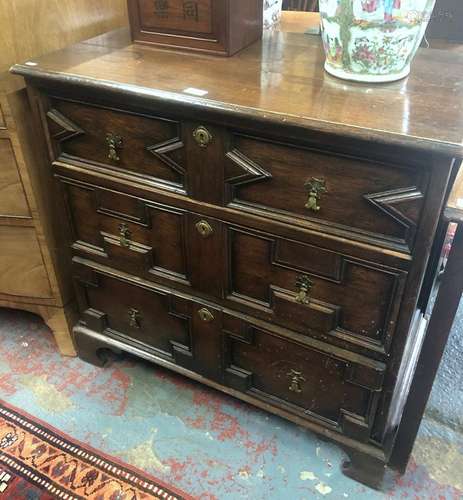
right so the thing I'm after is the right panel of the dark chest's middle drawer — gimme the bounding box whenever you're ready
[228,228,407,351]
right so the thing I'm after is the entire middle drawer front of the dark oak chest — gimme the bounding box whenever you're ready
[59,177,407,355]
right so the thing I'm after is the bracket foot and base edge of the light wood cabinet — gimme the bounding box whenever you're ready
[0,300,78,357]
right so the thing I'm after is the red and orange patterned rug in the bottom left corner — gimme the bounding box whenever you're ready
[0,401,192,500]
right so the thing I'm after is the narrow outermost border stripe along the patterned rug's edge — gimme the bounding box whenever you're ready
[0,399,194,500]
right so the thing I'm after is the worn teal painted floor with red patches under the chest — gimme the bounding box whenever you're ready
[0,310,463,500]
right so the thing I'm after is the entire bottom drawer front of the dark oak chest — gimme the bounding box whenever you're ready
[74,258,385,441]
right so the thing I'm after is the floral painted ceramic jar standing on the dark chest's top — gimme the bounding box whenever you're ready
[320,0,436,82]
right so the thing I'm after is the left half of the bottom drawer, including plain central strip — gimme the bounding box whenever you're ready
[73,259,222,380]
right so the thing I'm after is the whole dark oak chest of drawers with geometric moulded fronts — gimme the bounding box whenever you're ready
[14,24,463,486]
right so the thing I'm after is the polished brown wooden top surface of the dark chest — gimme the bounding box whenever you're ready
[13,25,463,157]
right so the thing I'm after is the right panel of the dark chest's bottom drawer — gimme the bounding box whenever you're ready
[223,314,384,440]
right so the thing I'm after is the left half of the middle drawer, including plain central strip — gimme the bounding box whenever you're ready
[60,177,223,297]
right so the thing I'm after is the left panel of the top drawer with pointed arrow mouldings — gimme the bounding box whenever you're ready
[47,99,186,193]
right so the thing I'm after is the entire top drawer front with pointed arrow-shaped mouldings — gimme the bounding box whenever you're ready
[43,98,430,253]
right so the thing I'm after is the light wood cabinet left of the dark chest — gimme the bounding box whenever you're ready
[0,0,128,356]
